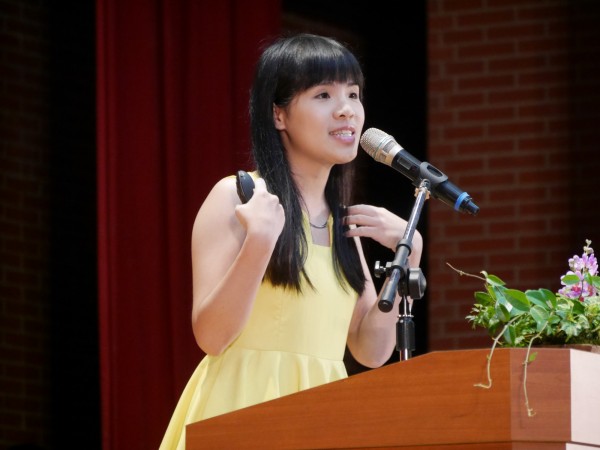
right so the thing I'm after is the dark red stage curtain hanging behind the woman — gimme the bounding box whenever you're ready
[97,0,281,450]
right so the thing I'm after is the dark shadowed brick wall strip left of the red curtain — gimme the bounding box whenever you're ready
[0,0,50,446]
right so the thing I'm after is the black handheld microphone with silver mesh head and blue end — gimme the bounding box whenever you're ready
[360,128,479,215]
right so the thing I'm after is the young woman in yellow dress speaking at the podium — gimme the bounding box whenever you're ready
[161,34,422,449]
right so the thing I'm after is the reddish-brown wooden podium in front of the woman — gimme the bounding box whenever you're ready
[186,348,600,450]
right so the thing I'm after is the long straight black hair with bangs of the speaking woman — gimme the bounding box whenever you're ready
[250,34,365,293]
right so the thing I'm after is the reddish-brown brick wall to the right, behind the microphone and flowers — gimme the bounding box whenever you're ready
[427,0,600,350]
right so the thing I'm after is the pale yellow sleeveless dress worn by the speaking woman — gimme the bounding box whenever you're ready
[160,217,357,450]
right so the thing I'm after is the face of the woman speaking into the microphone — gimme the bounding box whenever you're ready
[273,82,365,168]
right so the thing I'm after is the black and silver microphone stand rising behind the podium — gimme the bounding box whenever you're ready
[375,179,430,361]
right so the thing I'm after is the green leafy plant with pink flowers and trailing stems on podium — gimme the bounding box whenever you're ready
[450,240,600,415]
